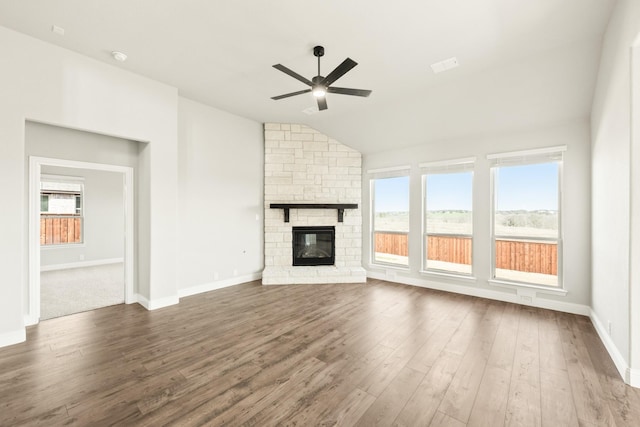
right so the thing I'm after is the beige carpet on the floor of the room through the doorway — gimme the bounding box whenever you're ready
[40,263,124,320]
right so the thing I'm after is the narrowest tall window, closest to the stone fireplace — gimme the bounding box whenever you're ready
[369,171,409,267]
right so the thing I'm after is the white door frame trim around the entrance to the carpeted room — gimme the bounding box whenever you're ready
[25,156,137,325]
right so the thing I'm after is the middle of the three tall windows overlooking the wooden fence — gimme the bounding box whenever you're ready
[420,158,475,275]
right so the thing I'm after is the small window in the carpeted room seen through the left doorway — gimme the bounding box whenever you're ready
[40,175,84,246]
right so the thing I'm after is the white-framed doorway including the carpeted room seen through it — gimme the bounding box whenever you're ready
[26,156,135,324]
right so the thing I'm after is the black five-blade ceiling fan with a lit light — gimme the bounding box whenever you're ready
[271,46,371,110]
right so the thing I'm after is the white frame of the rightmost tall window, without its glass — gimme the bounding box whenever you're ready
[487,145,567,295]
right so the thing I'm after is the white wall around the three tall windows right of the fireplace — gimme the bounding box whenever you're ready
[362,120,591,314]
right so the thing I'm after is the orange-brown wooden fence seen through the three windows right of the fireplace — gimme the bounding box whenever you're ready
[375,232,558,275]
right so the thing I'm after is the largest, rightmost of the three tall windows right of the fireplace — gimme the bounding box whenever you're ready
[489,147,565,287]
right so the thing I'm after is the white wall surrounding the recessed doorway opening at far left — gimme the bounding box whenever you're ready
[0,27,178,345]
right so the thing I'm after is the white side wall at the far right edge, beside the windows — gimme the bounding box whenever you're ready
[591,0,640,384]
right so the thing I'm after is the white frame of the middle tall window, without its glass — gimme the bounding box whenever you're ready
[418,157,476,279]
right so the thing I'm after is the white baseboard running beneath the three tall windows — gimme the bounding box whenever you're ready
[367,270,591,316]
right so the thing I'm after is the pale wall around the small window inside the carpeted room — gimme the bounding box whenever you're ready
[39,166,124,267]
